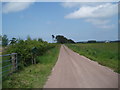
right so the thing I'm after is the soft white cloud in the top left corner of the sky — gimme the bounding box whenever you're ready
[2,0,35,13]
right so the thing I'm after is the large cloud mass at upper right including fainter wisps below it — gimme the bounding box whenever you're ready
[64,3,118,29]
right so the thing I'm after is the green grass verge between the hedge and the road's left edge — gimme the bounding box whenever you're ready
[2,45,60,88]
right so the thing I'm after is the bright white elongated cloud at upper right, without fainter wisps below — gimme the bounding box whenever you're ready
[65,3,118,19]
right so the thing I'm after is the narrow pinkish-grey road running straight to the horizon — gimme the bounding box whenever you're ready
[44,45,118,88]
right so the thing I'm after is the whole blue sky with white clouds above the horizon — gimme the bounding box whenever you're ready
[0,2,118,42]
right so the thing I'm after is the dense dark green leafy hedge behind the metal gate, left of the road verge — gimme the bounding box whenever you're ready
[5,39,55,68]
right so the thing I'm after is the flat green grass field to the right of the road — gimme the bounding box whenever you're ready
[67,43,120,73]
